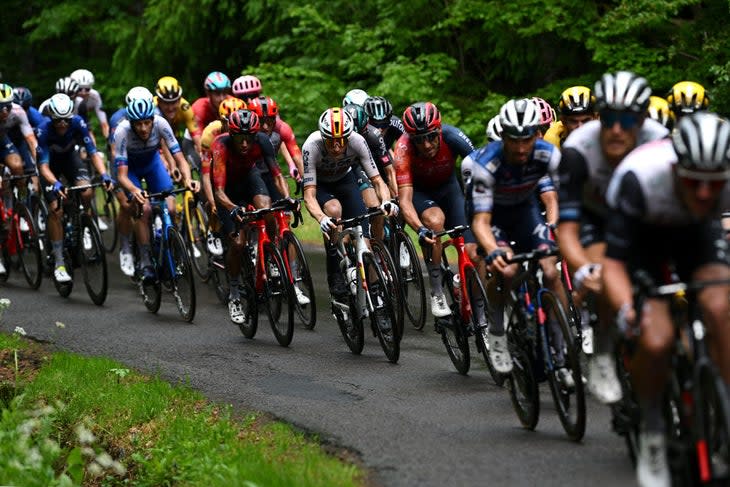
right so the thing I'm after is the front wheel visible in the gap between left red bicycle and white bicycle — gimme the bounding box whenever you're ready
[281,231,317,330]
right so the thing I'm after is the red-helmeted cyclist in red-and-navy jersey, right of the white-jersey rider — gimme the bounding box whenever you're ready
[394,102,477,318]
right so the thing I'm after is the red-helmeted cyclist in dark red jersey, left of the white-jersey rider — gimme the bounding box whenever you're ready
[211,110,289,324]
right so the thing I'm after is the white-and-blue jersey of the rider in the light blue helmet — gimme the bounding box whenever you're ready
[114,115,180,171]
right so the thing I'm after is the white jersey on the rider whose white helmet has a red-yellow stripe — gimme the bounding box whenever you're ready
[302,132,379,188]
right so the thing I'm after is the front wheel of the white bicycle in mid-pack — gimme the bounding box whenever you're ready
[363,253,400,363]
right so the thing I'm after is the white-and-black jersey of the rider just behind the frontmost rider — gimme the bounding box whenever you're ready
[559,119,669,222]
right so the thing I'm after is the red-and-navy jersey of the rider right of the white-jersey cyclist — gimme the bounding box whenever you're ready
[394,124,474,191]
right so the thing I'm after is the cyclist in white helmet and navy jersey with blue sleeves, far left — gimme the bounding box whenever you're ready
[38,93,112,282]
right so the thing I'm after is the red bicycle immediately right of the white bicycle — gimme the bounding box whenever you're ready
[426,225,494,385]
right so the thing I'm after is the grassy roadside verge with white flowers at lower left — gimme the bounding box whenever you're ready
[0,334,367,487]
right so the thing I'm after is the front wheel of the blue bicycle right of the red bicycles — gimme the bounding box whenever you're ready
[540,291,586,441]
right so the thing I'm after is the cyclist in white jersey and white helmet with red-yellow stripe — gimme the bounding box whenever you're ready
[302,107,396,299]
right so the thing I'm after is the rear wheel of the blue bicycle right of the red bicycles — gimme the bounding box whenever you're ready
[507,308,540,430]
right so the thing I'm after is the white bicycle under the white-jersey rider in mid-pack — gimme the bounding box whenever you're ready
[332,208,400,363]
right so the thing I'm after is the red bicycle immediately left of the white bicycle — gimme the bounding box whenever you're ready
[230,201,296,347]
